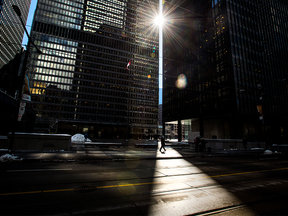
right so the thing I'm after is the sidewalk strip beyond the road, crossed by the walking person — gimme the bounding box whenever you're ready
[0,146,276,162]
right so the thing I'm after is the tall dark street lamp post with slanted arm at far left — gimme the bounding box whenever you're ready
[9,5,42,152]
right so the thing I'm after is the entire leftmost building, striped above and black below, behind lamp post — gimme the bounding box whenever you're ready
[0,0,31,135]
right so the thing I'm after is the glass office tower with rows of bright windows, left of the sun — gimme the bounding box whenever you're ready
[29,0,158,138]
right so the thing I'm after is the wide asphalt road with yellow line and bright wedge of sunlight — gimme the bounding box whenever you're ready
[0,149,288,216]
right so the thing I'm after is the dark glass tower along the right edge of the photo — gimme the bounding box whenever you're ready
[227,0,288,140]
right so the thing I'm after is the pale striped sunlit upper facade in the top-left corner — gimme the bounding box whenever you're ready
[0,0,31,68]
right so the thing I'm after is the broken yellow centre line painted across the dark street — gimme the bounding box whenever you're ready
[0,167,288,196]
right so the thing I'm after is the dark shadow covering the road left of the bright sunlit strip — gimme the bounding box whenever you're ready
[0,146,157,215]
